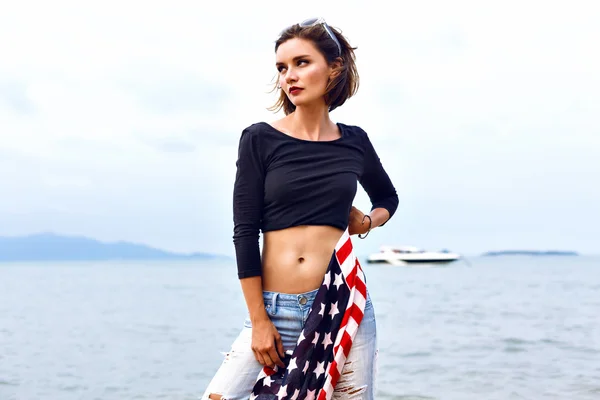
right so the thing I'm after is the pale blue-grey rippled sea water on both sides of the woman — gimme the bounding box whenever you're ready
[0,256,600,400]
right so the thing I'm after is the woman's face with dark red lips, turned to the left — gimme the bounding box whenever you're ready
[275,38,333,107]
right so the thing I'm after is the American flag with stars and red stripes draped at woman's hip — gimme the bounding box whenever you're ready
[250,229,367,400]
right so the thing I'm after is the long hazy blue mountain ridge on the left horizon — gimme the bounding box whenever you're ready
[0,233,227,262]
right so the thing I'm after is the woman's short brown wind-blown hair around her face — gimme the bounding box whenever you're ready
[268,24,359,115]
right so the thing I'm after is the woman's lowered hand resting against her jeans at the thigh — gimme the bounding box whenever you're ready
[252,318,285,368]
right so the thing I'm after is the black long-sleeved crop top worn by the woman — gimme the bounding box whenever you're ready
[233,122,398,279]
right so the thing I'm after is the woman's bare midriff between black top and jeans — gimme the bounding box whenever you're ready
[262,225,344,294]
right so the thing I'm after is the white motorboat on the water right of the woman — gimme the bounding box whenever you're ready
[367,246,461,265]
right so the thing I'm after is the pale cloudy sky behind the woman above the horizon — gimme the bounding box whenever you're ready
[0,0,600,255]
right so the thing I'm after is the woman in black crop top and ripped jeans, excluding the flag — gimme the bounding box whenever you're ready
[203,18,398,399]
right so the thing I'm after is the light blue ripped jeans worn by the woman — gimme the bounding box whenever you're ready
[202,290,377,400]
